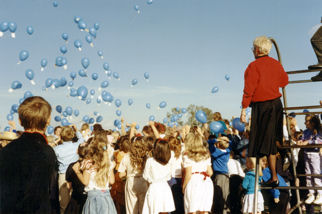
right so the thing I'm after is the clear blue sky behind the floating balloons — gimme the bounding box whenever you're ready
[0,0,322,129]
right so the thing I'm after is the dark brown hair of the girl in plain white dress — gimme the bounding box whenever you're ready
[152,139,171,165]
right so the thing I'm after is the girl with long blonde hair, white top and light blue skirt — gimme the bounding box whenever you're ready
[73,138,117,214]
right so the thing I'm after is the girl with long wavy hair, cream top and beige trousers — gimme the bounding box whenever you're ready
[118,137,148,214]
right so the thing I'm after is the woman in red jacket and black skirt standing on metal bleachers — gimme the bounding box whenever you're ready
[240,36,288,186]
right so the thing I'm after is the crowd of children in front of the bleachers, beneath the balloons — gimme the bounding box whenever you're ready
[0,96,322,214]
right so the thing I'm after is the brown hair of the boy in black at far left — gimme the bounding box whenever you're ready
[18,97,51,130]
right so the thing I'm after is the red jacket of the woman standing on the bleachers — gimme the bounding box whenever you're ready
[242,56,288,108]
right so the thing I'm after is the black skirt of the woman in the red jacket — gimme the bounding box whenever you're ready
[248,98,283,157]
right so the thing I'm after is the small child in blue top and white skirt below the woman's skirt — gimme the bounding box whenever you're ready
[242,157,264,213]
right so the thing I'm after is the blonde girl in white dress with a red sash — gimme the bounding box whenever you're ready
[183,132,214,213]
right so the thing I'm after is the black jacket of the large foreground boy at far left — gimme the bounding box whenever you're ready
[0,132,60,214]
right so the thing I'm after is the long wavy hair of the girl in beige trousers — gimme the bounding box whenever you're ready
[130,137,148,172]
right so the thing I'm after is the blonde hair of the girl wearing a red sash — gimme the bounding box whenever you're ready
[184,133,210,162]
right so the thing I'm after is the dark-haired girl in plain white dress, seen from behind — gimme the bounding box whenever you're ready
[142,139,175,214]
